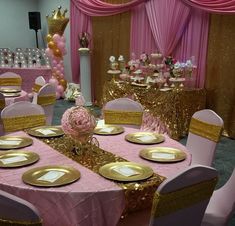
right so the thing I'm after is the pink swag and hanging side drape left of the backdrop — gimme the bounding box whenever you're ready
[70,0,146,83]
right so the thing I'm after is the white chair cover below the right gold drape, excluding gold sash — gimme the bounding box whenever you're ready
[186,109,224,166]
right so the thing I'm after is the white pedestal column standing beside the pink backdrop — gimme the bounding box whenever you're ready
[78,48,92,106]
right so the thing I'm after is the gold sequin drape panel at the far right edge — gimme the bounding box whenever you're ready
[205,14,235,138]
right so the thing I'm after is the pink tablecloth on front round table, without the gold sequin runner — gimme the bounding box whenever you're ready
[0,128,191,226]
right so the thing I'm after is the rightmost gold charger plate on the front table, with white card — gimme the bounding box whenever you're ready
[139,147,186,162]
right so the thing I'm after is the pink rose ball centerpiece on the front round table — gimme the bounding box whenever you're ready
[61,106,96,144]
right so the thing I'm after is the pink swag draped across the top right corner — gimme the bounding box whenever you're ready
[181,0,235,14]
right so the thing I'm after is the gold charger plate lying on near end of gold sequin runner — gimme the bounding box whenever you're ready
[99,162,153,181]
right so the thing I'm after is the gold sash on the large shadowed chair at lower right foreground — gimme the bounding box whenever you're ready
[151,177,218,218]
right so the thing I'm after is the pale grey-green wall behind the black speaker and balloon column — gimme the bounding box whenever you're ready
[0,0,72,82]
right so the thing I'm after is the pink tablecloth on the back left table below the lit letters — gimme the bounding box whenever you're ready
[0,67,51,93]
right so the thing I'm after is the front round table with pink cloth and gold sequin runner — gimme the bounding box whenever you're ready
[0,127,191,226]
